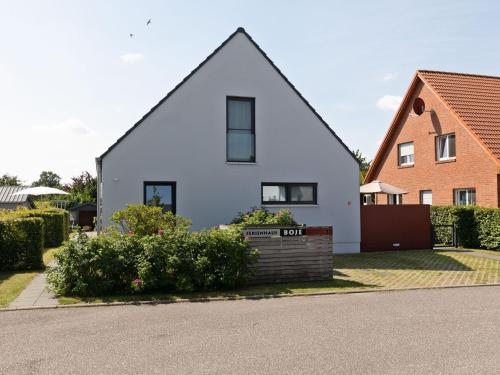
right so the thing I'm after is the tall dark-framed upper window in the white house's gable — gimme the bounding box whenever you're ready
[226,96,255,163]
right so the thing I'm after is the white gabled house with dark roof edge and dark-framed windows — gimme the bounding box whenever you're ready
[96,28,360,252]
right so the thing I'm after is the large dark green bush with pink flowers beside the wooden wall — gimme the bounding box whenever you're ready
[48,227,257,296]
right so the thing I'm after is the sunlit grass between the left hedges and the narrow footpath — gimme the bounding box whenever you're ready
[0,247,61,307]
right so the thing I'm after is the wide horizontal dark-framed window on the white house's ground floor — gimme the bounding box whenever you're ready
[261,182,318,204]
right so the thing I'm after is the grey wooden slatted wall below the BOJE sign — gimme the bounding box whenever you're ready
[249,227,333,284]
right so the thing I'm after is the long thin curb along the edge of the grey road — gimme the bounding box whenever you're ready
[0,283,500,313]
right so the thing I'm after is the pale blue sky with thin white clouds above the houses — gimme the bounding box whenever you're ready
[0,0,500,184]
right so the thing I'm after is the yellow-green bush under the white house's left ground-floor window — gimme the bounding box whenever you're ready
[111,204,190,236]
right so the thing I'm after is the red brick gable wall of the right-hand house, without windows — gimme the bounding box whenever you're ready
[372,82,500,207]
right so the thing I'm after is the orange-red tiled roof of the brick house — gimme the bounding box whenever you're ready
[365,70,500,182]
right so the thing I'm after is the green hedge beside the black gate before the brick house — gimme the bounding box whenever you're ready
[431,206,500,250]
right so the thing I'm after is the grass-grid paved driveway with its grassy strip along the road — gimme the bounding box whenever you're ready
[59,251,500,304]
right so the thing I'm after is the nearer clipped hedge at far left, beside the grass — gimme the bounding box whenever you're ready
[0,218,44,271]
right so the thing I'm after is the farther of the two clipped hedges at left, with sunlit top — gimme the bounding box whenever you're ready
[0,208,69,247]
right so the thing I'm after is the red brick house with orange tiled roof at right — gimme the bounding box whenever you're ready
[365,70,500,207]
